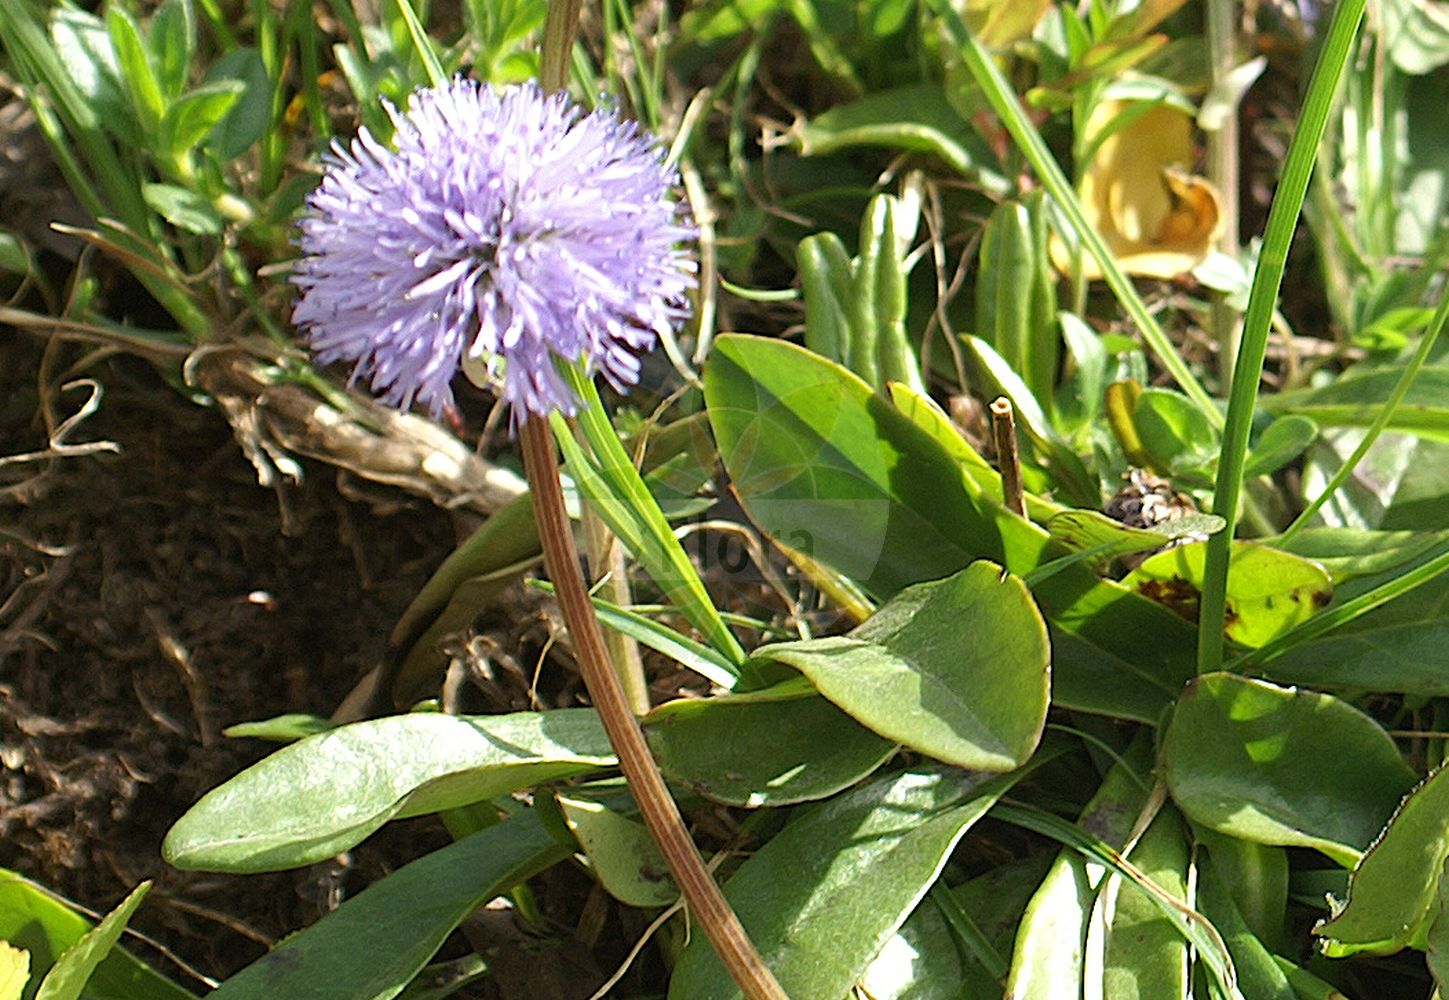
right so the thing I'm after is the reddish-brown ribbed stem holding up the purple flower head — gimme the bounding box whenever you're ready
[519,416,785,1000]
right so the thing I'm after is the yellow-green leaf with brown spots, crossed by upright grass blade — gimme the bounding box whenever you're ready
[1122,542,1333,649]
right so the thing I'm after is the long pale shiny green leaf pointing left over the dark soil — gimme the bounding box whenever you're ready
[162,709,614,872]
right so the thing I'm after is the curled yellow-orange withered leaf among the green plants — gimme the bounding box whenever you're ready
[1052,101,1223,278]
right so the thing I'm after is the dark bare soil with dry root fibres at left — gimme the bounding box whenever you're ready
[0,332,469,987]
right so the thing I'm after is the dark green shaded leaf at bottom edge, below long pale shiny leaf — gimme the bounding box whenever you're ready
[207,810,569,1000]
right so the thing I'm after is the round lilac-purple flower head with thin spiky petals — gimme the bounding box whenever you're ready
[293,80,694,419]
